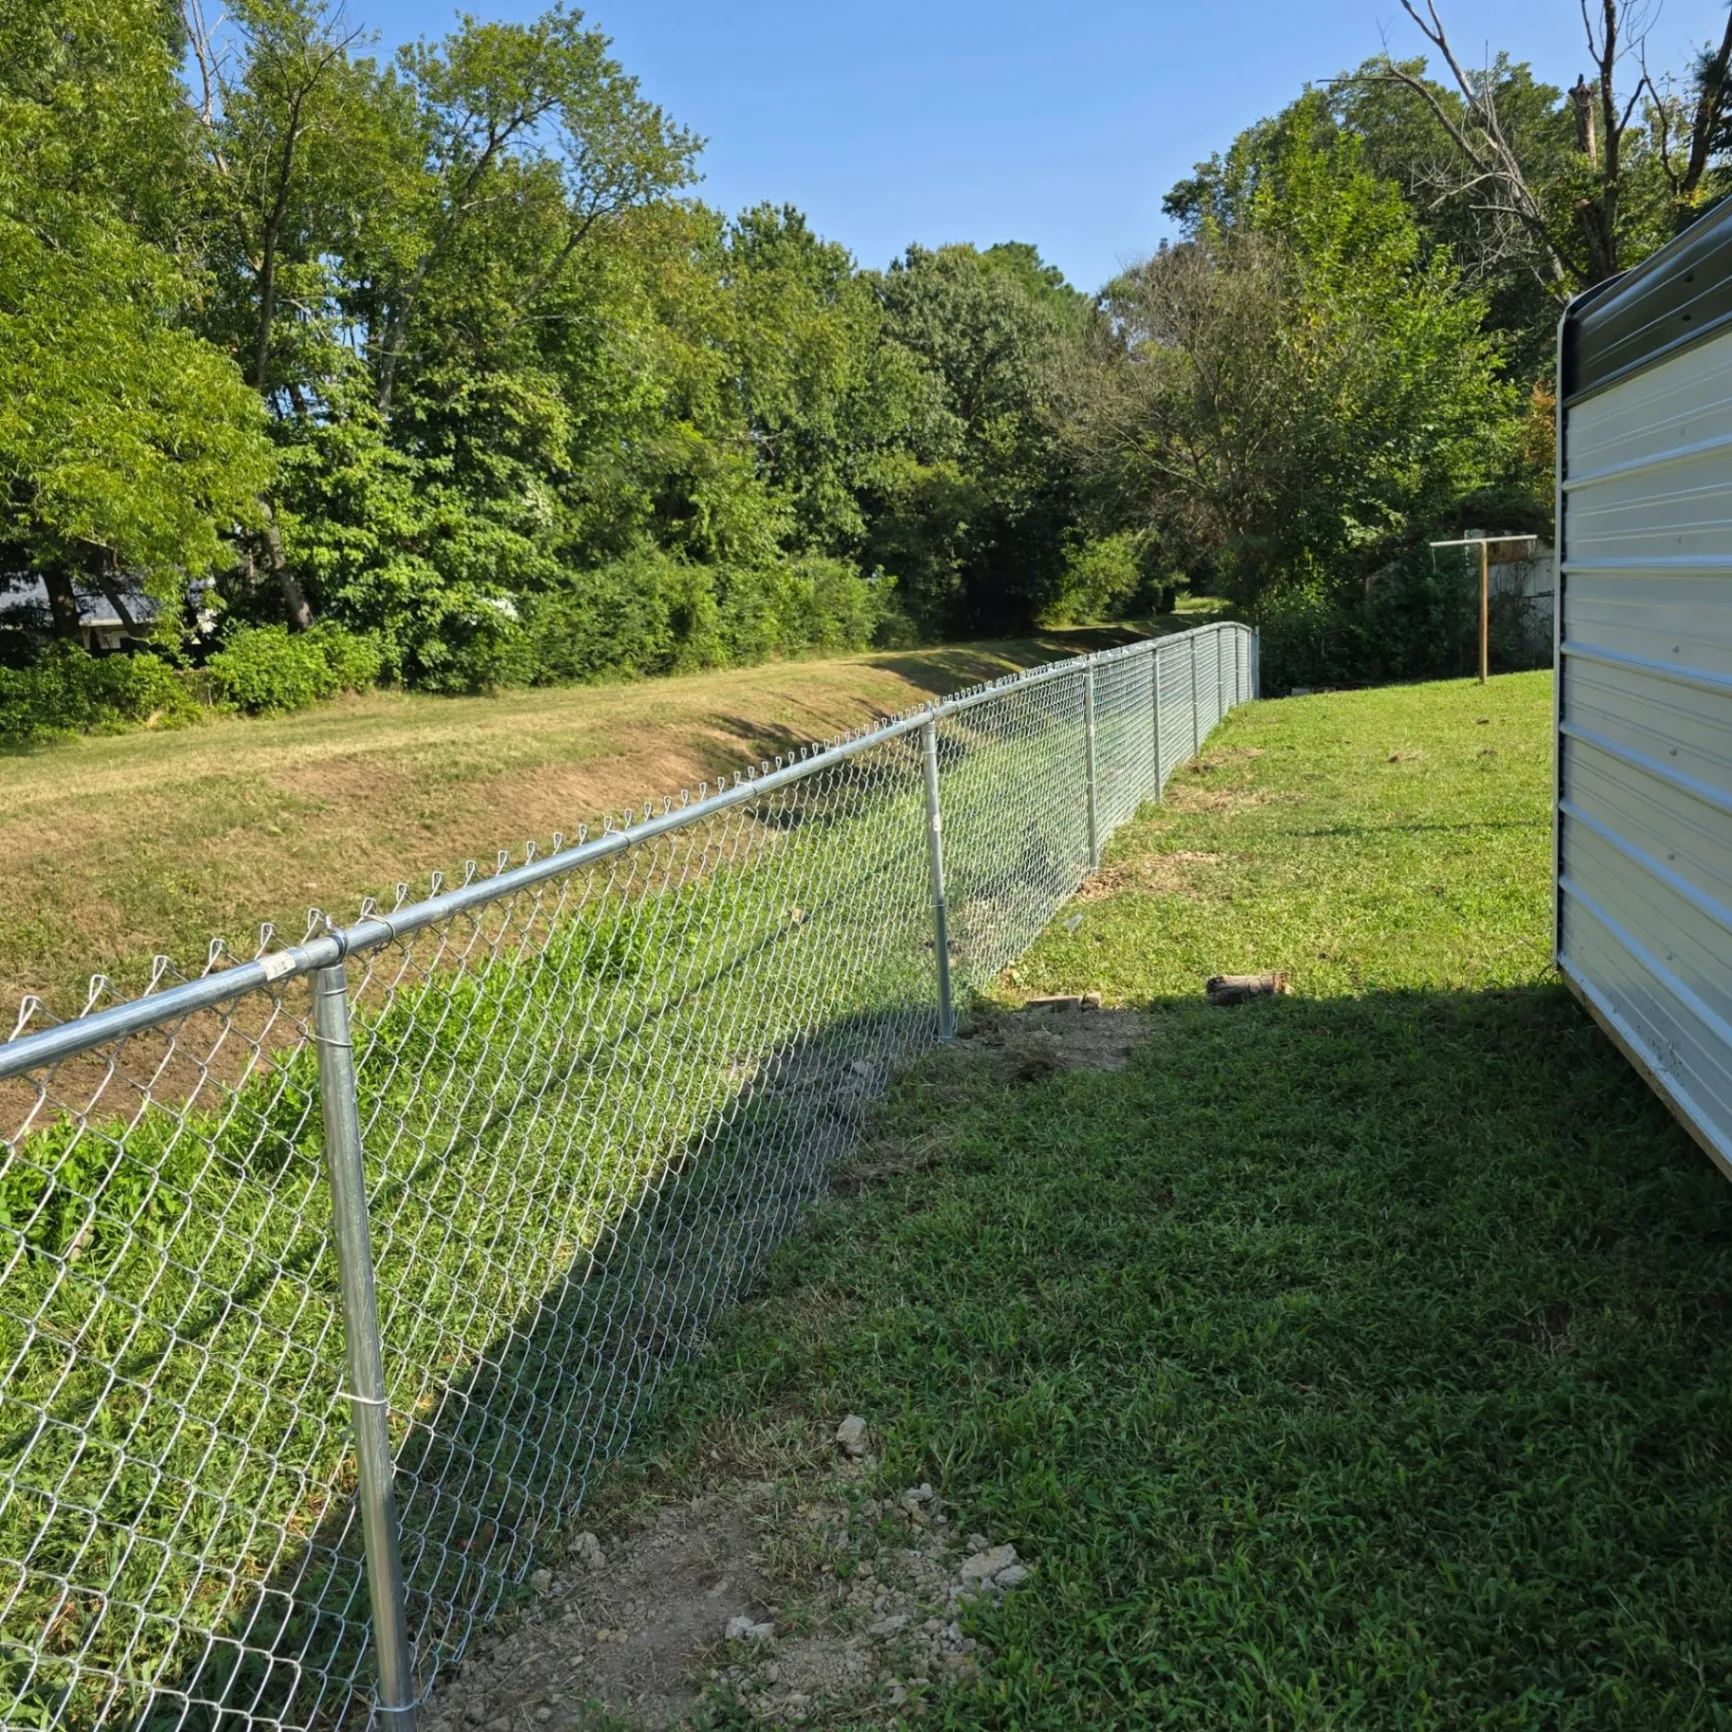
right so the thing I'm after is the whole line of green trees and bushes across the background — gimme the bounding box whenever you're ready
[0,0,1732,731]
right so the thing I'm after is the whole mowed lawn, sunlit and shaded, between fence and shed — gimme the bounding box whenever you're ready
[637,675,1732,1732]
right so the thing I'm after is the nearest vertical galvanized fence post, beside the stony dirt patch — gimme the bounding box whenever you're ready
[313,963,416,1732]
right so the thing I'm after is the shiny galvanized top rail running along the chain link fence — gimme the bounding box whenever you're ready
[0,620,1251,1083]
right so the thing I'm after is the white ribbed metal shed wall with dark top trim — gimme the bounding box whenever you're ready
[1554,204,1732,1176]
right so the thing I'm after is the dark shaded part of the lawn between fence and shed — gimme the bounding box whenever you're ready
[650,979,1732,1727]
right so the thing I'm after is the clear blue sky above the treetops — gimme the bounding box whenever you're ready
[346,0,1723,289]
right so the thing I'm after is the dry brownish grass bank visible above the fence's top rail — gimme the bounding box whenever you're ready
[0,630,1133,1011]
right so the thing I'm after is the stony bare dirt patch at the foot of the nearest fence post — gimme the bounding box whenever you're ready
[421,1427,1032,1732]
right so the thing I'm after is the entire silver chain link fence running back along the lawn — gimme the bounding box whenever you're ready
[0,624,1257,1732]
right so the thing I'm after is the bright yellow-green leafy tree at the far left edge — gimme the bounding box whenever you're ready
[0,0,270,636]
